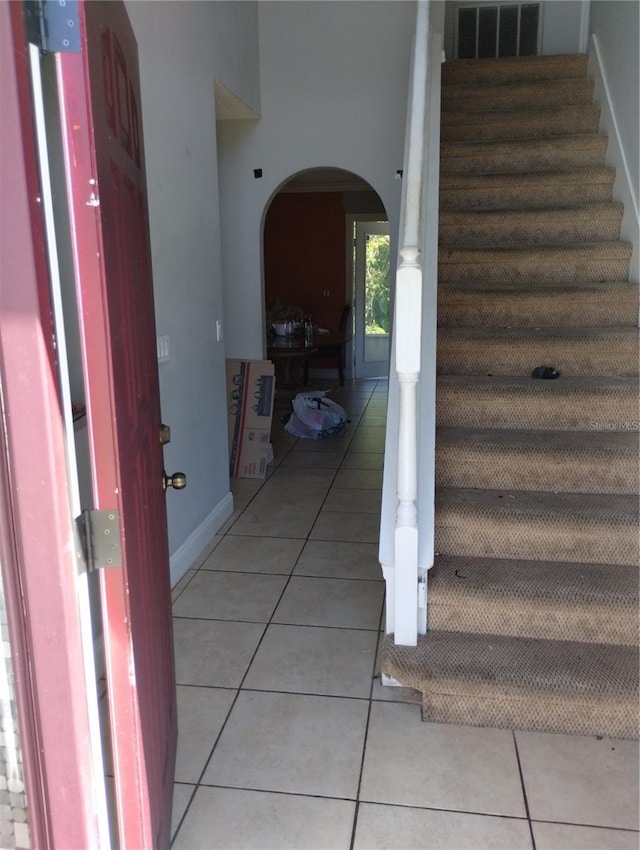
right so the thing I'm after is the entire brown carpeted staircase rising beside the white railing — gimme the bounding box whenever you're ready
[383,55,639,737]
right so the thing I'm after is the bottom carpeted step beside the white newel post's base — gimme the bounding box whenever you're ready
[382,631,638,738]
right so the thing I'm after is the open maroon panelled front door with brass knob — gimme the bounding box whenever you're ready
[57,0,177,850]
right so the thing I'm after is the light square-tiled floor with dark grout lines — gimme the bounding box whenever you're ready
[168,381,639,850]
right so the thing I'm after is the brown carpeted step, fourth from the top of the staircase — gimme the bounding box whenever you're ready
[440,133,608,174]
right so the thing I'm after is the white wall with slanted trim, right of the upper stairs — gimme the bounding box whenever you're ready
[589,0,640,282]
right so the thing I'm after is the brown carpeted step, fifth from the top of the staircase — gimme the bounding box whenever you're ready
[440,180,613,210]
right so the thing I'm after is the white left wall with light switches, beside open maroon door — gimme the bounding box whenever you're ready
[127,0,260,581]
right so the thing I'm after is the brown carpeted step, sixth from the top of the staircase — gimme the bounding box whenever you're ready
[438,211,622,248]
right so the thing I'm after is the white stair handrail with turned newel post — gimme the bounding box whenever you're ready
[380,0,442,646]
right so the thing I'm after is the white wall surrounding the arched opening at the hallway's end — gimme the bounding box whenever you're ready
[218,0,415,358]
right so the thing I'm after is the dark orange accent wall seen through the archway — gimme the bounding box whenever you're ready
[264,192,350,329]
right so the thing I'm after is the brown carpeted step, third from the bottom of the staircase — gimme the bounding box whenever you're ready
[436,487,639,565]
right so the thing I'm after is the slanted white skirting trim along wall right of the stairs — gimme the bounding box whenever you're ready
[589,33,640,283]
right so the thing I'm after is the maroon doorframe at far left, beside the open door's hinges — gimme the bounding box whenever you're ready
[0,3,104,848]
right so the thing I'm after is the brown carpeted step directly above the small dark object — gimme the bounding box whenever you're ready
[437,327,639,377]
